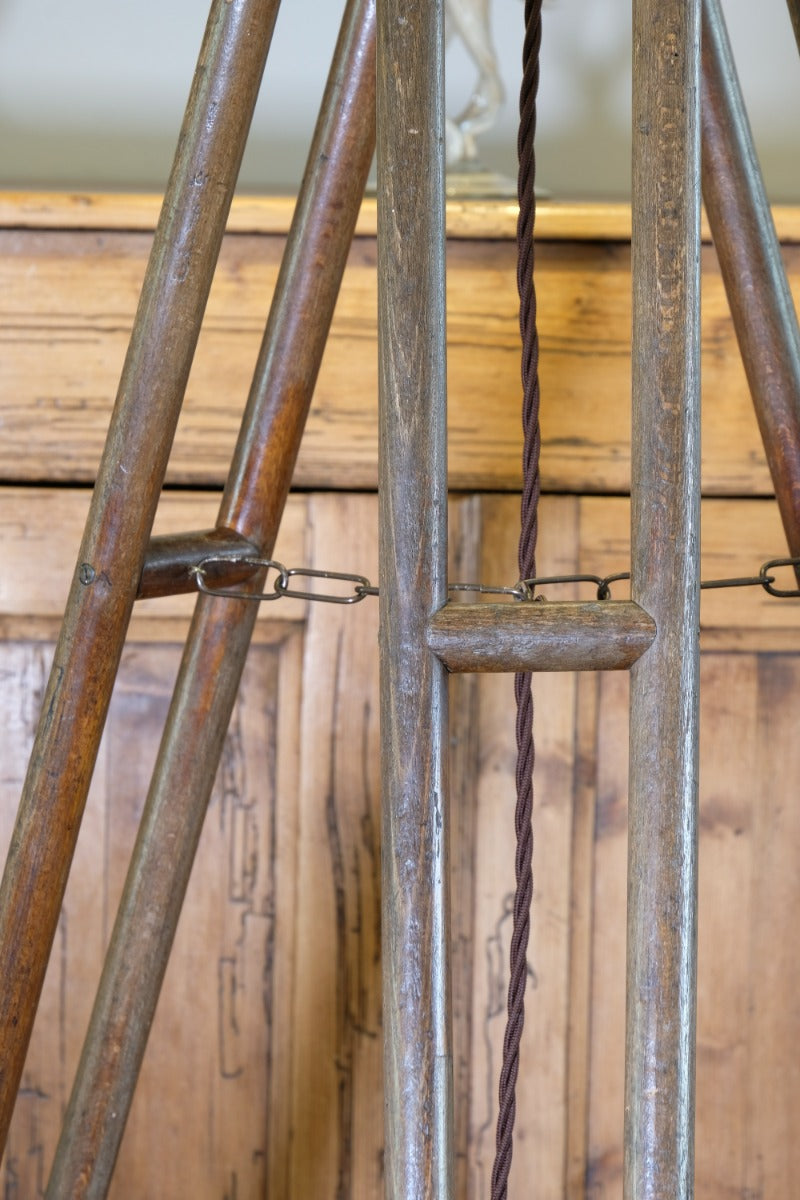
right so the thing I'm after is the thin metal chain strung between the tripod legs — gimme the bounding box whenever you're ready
[192,554,800,604]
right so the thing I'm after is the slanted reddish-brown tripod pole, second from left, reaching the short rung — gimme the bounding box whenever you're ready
[47,0,375,1198]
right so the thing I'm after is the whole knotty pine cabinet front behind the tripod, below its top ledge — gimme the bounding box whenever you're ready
[0,196,800,1200]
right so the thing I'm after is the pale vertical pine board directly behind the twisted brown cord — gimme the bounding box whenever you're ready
[467,497,577,1200]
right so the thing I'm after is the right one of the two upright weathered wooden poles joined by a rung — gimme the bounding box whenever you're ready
[624,0,699,1200]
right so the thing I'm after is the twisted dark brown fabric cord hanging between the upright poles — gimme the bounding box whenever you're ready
[492,0,542,1200]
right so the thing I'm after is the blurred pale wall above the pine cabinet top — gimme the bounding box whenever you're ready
[0,0,800,202]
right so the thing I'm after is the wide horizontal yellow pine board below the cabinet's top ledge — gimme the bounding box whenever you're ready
[0,230,800,496]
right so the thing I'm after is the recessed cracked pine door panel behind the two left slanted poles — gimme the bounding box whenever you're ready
[0,626,302,1200]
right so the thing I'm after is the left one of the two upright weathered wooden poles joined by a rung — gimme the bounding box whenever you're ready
[378,0,452,1200]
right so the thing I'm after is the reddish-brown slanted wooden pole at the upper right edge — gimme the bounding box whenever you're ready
[700,0,800,566]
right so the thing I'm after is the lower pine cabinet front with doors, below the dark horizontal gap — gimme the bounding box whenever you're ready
[0,490,800,1200]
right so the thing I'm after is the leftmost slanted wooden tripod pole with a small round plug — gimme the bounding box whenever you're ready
[0,0,284,1151]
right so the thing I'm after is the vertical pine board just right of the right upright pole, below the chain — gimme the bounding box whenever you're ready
[697,654,758,1196]
